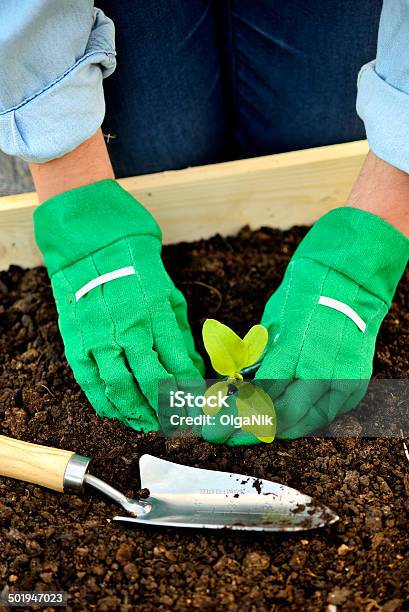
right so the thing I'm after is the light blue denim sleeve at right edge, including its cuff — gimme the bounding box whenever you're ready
[357,0,409,172]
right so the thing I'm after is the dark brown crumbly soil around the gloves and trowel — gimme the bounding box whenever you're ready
[0,228,409,612]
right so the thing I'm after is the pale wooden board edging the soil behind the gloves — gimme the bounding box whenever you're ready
[0,141,368,270]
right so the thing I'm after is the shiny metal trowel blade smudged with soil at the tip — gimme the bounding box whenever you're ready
[114,455,339,532]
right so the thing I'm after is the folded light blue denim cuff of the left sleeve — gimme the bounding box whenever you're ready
[0,9,116,163]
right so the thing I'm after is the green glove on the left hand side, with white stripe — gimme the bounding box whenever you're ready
[34,180,203,431]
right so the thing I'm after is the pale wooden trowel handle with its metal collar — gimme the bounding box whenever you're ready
[0,436,89,492]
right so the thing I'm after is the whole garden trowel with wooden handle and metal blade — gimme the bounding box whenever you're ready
[0,436,338,531]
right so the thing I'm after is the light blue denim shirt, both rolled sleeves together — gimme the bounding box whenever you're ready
[0,0,409,172]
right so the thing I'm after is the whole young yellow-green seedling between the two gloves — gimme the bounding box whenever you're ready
[203,319,276,442]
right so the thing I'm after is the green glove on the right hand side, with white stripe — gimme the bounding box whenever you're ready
[206,207,409,445]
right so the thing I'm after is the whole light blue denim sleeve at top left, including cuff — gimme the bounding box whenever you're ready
[0,0,116,162]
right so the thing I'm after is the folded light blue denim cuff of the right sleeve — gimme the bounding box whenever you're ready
[356,61,409,173]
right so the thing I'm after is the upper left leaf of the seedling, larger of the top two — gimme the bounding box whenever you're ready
[202,319,247,377]
